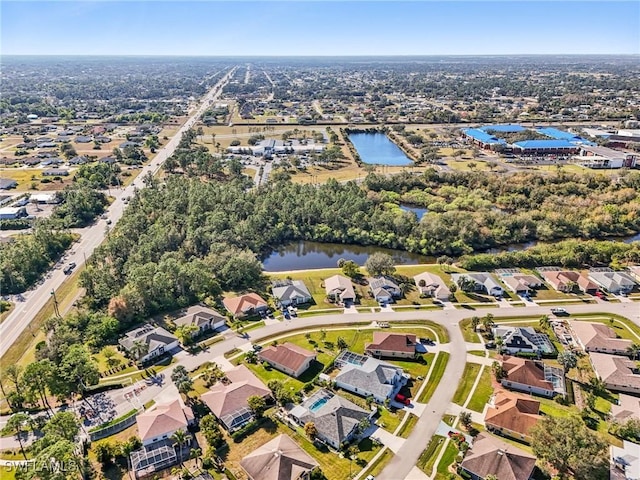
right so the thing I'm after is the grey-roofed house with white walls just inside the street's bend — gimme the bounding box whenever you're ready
[334,350,407,403]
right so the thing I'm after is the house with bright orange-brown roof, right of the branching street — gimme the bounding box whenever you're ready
[484,390,541,443]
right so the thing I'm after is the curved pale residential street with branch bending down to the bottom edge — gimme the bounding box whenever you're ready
[0,303,640,480]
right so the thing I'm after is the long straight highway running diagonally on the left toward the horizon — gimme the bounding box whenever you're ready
[0,67,237,357]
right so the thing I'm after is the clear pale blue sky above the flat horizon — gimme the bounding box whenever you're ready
[0,0,640,55]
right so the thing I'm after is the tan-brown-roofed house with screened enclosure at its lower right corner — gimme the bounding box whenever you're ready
[201,365,271,432]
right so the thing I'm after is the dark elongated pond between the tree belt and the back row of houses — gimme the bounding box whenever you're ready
[262,241,435,272]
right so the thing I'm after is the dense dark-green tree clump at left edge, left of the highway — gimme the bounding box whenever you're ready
[0,221,73,295]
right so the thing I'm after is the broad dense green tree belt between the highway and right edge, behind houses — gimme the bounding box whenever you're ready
[81,171,640,320]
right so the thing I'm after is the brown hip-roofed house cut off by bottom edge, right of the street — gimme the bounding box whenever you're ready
[460,433,536,480]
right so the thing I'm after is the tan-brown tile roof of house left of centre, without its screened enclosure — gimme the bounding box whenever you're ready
[201,365,271,418]
